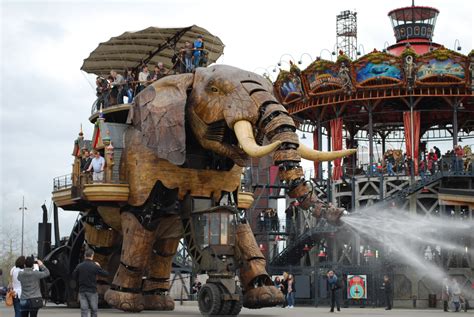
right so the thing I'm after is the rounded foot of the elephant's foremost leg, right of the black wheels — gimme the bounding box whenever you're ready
[243,285,285,309]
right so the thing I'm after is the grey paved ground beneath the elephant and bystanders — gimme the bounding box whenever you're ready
[0,303,474,317]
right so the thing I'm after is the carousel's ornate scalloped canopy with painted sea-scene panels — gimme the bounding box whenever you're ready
[274,46,474,133]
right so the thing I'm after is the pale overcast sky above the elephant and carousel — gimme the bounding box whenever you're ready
[0,0,474,253]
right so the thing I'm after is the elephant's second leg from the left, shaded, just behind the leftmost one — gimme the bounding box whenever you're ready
[143,215,183,310]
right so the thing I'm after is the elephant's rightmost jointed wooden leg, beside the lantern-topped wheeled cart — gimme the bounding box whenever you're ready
[236,224,284,308]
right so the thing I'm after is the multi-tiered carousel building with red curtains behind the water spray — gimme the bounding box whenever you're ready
[252,2,474,307]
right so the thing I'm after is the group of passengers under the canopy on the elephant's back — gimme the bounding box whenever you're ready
[96,35,209,110]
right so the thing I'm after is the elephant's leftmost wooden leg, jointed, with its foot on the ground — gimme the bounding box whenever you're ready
[105,212,156,312]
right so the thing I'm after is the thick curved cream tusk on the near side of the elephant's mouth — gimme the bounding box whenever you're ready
[234,120,281,157]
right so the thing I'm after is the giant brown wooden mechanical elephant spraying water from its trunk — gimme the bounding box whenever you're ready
[90,65,354,315]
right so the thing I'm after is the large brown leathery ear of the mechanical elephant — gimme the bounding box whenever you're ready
[127,74,194,165]
